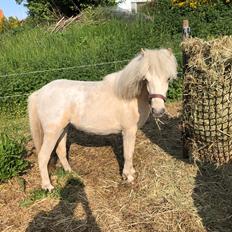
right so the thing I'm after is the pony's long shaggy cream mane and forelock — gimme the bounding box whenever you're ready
[115,49,177,99]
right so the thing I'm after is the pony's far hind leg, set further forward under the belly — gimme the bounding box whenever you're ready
[56,130,72,172]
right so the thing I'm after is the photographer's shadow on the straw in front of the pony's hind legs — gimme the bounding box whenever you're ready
[26,178,101,232]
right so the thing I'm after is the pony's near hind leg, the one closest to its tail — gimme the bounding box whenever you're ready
[38,131,62,191]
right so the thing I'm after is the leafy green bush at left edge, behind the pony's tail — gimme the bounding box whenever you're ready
[0,134,29,182]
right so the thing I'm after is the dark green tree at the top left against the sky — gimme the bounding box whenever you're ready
[15,0,115,19]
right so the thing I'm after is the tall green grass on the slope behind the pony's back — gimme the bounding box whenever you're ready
[0,15,184,108]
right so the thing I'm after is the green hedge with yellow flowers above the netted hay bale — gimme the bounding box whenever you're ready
[144,0,232,38]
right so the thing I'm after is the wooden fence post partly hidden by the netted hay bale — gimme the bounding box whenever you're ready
[182,19,191,159]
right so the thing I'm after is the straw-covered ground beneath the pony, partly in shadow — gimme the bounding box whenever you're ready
[0,103,232,232]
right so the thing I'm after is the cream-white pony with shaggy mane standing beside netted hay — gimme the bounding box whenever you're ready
[28,49,177,191]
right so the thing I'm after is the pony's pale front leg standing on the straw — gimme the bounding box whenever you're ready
[122,127,137,183]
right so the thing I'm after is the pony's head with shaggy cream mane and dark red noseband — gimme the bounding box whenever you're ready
[117,49,177,117]
